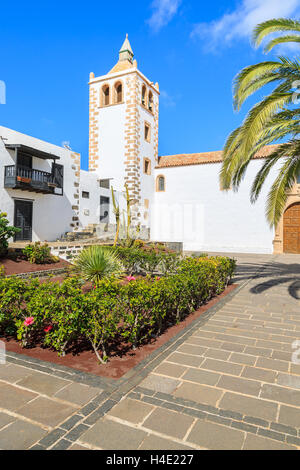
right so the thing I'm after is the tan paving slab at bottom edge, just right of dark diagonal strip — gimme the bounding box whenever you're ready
[80,418,147,450]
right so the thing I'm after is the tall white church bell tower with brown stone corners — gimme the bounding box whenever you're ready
[89,35,159,226]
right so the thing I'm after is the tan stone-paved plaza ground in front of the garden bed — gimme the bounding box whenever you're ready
[0,255,300,450]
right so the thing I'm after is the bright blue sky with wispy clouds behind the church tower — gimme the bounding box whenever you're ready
[0,0,300,168]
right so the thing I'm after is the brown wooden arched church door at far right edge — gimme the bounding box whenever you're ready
[283,203,300,253]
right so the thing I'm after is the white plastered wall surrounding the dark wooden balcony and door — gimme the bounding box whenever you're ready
[0,126,79,241]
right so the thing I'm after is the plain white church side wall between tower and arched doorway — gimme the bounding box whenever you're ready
[151,160,276,253]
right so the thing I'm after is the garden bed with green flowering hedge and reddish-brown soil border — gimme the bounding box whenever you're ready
[0,252,235,378]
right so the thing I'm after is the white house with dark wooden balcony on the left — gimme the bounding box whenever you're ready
[0,126,80,241]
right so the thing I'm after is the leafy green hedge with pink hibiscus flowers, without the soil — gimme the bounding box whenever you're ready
[0,257,235,362]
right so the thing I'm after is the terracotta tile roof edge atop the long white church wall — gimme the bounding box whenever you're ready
[156,145,278,168]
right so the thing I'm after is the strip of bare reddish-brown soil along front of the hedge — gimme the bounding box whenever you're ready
[1,284,237,379]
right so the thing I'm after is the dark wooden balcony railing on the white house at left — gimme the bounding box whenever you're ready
[4,165,61,194]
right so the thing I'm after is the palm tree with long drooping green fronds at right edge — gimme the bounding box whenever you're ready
[220,19,300,227]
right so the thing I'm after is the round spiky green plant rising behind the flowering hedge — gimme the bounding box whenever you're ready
[74,245,124,284]
